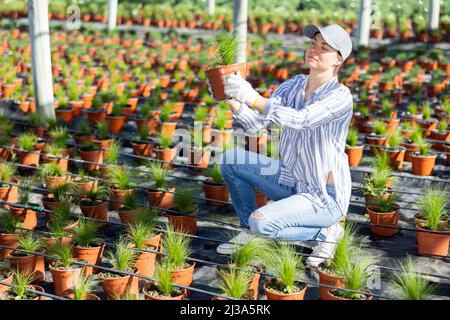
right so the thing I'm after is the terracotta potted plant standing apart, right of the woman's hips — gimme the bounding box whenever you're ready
[367,193,400,236]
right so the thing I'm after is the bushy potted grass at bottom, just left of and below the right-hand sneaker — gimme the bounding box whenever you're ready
[263,242,306,300]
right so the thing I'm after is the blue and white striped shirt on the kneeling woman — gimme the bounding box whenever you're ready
[233,74,353,214]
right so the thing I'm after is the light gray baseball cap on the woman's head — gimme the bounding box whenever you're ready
[303,24,352,61]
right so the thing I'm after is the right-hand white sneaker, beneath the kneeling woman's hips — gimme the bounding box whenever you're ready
[306,223,344,268]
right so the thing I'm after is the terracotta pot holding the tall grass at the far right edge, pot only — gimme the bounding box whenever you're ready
[416,221,450,257]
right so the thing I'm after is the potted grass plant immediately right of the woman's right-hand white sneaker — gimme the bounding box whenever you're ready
[316,223,359,300]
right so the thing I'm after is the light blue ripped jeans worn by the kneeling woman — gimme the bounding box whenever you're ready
[219,148,343,241]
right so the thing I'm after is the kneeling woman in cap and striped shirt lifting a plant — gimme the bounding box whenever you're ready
[217,25,353,266]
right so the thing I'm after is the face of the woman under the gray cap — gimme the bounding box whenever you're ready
[305,33,341,71]
